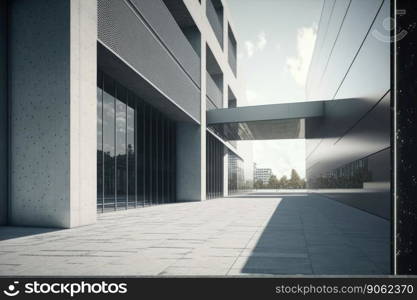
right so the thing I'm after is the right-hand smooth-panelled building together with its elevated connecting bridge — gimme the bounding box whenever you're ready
[207,0,392,219]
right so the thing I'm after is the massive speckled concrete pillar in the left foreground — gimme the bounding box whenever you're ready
[9,0,97,228]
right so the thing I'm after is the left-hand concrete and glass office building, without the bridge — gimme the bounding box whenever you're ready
[0,0,247,228]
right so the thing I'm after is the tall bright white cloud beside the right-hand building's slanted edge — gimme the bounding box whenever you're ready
[286,24,317,87]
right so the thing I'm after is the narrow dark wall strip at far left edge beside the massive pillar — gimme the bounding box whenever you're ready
[0,1,9,225]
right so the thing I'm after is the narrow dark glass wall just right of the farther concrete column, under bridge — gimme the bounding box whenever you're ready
[206,132,224,199]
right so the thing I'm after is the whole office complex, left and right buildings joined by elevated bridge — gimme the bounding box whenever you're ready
[0,0,391,228]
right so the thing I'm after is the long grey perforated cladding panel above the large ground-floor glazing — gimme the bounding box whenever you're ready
[98,0,201,121]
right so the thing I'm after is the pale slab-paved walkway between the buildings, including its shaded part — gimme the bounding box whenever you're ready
[0,193,390,276]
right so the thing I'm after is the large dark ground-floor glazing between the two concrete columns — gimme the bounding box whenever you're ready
[97,71,176,212]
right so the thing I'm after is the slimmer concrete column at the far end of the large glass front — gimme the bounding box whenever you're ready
[177,36,206,201]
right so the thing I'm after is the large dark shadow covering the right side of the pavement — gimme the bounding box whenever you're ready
[231,193,391,275]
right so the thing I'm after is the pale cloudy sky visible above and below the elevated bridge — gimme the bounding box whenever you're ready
[227,0,323,177]
